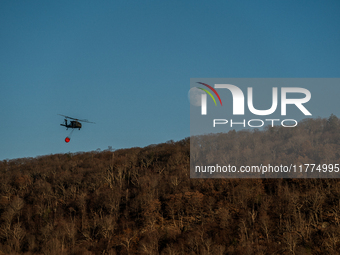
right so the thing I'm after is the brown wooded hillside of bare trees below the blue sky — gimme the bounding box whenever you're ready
[0,115,340,255]
